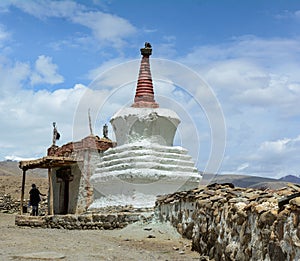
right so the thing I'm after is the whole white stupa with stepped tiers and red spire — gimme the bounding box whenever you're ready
[90,43,201,209]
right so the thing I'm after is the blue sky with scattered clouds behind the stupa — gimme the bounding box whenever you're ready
[0,0,300,177]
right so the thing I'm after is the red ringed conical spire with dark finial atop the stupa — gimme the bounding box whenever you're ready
[131,43,159,108]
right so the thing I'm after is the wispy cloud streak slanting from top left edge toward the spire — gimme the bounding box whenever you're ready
[6,0,137,48]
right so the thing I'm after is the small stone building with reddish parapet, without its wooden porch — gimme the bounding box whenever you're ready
[48,135,114,214]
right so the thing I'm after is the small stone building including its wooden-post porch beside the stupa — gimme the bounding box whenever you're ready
[20,133,115,215]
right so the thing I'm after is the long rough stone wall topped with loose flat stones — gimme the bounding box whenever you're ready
[155,184,300,261]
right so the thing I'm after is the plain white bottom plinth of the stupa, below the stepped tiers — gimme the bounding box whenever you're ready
[89,175,201,210]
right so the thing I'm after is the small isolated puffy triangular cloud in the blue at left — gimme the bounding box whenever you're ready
[30,55,64,85]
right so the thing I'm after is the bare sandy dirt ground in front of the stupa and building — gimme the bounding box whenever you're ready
[0,214,199,261]
